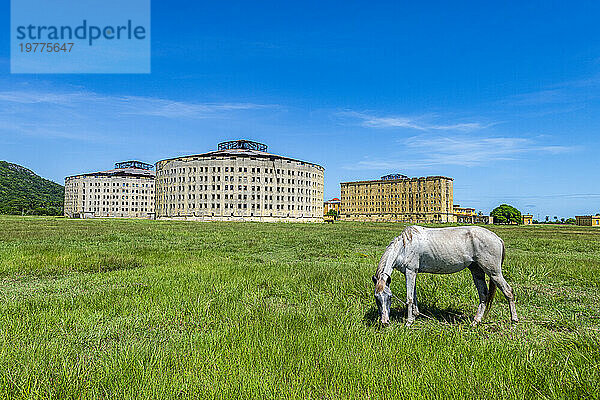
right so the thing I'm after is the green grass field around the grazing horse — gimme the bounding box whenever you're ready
[0,217,600,399]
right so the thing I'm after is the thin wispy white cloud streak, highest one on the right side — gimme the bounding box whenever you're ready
[338,111,490,132]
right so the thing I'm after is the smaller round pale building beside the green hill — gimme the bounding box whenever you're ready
[64,161,155,219]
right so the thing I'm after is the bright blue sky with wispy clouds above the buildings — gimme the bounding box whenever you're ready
[0,0,600,219]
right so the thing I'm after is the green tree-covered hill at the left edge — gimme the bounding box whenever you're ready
[0,161,65,215]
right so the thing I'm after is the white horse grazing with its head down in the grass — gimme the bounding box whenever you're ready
[373,225,519,326]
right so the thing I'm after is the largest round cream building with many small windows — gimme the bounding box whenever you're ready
[156,140,325,222]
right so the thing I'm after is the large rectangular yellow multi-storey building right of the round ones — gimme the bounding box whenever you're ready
[340,174,455,223]
